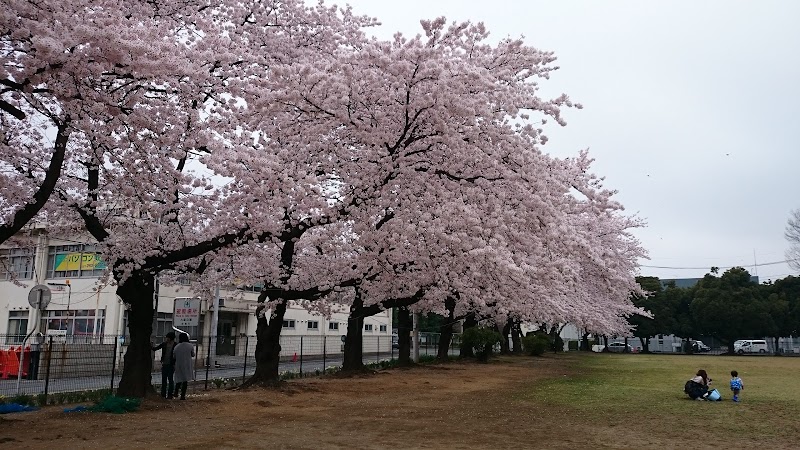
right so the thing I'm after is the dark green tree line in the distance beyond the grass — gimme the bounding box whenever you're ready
[630,267,800,353]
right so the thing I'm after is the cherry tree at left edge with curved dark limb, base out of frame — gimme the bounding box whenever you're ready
[0,0,169,243]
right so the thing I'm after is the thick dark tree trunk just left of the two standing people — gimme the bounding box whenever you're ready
[117,272,156,398]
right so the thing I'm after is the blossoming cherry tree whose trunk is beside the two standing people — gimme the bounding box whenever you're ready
[4,1,371,396]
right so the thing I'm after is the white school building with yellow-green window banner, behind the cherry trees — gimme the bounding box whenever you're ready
[0,228,392,356]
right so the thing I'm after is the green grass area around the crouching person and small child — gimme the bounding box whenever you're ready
[518,353,800,447]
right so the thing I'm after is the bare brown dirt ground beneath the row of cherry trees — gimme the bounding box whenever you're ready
[0,357,776,449]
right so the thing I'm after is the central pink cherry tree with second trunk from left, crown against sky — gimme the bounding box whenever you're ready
[222,16,638,376]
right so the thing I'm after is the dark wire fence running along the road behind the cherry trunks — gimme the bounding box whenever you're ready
[0,333,459,404]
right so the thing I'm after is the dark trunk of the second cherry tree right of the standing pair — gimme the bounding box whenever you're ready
[242,295,288,388]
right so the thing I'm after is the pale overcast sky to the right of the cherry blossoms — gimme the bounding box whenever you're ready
[338,0,800,280]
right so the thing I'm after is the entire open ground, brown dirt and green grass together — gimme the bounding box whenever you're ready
[0,352,800,450]
